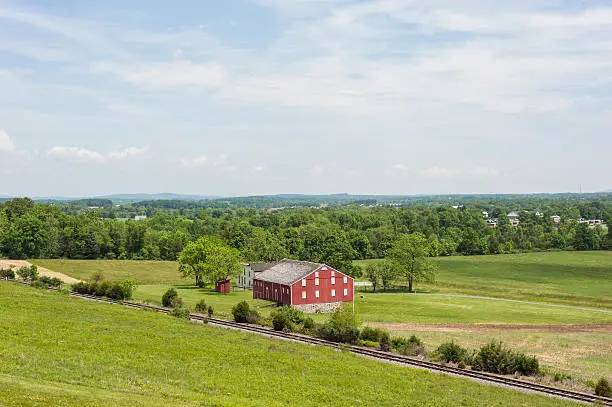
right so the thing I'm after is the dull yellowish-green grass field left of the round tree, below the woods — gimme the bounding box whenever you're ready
[32,260,186,284]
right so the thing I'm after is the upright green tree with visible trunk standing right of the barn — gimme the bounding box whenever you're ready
[386,232,438,292]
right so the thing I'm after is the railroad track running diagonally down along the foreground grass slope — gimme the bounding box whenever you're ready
[4,282,612,406]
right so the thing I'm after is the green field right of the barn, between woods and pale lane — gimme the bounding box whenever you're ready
[356,251,612,309]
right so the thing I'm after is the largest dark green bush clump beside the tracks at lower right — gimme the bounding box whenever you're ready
[472,342,540,376]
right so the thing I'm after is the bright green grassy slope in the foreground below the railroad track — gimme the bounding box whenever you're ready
[0,283,574,406]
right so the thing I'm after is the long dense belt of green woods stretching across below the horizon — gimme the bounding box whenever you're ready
[0,198,612,272]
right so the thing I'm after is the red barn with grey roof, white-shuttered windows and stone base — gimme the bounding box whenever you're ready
[253,259,354,312]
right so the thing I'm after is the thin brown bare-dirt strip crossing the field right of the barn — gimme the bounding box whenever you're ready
[368,322,612,333]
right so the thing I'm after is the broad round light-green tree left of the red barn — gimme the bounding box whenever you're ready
[178,237,242,287]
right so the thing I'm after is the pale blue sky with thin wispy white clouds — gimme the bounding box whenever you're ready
[0,0,612,196]
